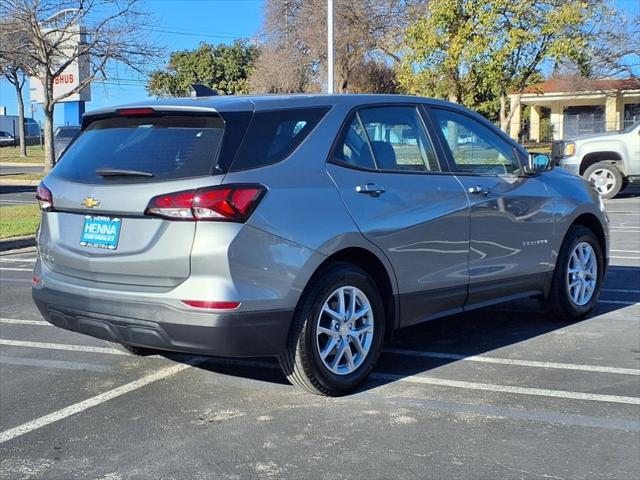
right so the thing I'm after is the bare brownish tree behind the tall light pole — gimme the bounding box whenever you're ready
[250,0,424,93]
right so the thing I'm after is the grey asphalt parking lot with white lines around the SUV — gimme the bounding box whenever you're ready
[0,191,640,480]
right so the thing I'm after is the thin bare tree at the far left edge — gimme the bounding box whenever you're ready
[0,21,27,157]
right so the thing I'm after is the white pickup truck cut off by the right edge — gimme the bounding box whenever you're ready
[552,122,640,198]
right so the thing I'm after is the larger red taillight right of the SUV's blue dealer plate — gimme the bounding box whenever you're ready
[145,185,267,223]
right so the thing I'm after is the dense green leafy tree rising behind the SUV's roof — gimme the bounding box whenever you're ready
[147,40,257,97]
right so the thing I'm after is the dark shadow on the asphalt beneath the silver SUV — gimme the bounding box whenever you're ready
[165,266,640,393]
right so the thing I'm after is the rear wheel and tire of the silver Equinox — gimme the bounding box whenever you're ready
[279,262,385,396]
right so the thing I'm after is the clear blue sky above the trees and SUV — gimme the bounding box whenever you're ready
[0,0,640,124]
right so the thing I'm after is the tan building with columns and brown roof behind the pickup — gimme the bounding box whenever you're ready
[509,77,640,142]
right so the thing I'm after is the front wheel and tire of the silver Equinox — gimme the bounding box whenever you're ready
[543,225,604,321]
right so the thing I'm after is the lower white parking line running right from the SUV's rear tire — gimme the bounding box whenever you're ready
[371,372,640,405]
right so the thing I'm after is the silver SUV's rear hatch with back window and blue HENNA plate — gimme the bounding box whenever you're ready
[39,108,245,287]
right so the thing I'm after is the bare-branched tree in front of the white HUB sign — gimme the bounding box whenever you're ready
[0,0,159,172]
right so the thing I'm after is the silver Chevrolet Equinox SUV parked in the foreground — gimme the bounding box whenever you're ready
[33,95,608,395]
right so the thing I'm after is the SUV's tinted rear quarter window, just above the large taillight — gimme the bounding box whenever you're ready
[230,107,329,172]
